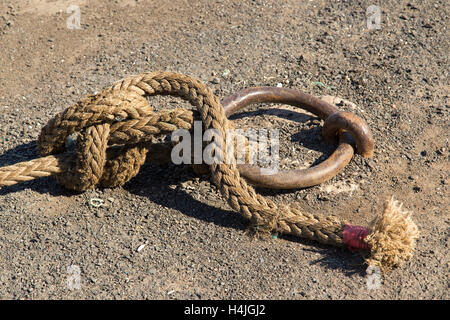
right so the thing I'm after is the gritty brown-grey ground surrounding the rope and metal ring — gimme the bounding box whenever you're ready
[0,0,450,299]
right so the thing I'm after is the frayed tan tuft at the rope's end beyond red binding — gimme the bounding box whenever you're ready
[365,197,419,272]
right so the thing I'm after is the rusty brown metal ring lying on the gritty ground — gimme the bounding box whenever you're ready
[221,87,373,189]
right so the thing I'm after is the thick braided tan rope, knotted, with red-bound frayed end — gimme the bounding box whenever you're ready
[0,72,418,270]
